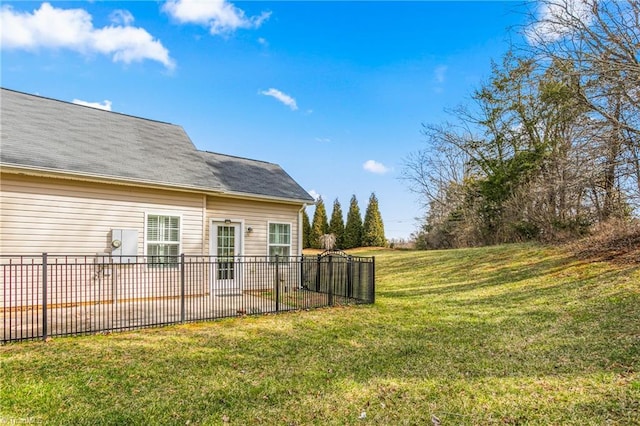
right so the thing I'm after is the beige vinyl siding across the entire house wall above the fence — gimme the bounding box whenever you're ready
[0,172,301,256]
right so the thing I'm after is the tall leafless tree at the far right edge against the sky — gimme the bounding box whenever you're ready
[524,0,640,210]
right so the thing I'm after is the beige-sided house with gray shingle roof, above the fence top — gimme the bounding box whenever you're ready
[0,89,314,294]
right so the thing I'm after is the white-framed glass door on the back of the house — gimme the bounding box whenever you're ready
[211,222,242,294]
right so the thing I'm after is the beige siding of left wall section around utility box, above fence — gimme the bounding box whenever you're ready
[0,173,205,255]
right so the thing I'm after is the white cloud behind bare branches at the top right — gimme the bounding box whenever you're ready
[525,0,593,45]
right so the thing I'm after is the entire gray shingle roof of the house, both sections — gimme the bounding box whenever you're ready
[0,88,312,200]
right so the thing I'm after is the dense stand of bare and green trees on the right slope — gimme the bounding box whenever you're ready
[402,0,640,248]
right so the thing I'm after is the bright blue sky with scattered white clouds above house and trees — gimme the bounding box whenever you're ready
[1,0,536,238]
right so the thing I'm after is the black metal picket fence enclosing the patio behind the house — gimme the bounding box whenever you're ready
[0,252,375,342]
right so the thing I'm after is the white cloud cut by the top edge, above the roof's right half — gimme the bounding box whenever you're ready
[162,0,271,34]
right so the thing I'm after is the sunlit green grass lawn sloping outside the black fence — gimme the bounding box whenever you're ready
[0,245,640,425]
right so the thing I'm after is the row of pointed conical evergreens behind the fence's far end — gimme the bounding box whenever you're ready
[302,193,387,250]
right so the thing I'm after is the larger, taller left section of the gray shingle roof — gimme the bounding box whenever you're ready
[0,89,220,189]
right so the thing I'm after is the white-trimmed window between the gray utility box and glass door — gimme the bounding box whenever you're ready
[146,214,180,264]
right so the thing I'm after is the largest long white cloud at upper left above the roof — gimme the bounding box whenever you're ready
[0,3,175,69]
